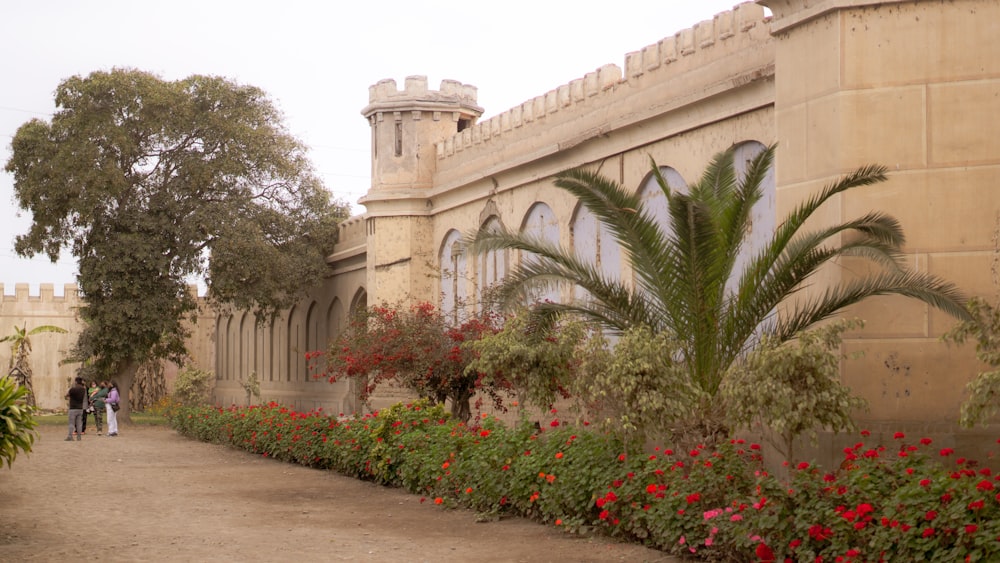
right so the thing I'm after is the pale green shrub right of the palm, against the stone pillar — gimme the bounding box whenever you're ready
[721,321,867,461]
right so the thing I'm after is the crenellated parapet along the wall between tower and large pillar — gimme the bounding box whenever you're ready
[437,2,770,160]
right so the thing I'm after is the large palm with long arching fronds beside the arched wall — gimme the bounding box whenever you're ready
[467,146,969,397]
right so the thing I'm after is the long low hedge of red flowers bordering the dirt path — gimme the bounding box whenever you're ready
[170,401,1000,563]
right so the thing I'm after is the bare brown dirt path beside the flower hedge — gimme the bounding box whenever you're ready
[0,426,677,563]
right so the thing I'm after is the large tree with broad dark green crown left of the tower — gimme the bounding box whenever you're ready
[6,69,348,420]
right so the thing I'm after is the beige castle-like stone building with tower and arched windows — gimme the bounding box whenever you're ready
[207,0,1000,462]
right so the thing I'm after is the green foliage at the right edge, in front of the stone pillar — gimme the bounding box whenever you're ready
[942,297,1000,428]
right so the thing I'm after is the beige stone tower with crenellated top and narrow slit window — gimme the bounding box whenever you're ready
[361,76,483,304]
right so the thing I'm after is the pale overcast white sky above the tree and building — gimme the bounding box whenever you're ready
[0,0,756,295]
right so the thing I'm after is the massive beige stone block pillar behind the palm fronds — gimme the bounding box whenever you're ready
[758,0,1000,450]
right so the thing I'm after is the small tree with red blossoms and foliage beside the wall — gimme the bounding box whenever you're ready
[324,303,509,421]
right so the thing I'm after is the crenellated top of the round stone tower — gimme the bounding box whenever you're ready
[361,76,483,117]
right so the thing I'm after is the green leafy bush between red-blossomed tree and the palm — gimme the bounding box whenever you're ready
[462,310,587,408]
